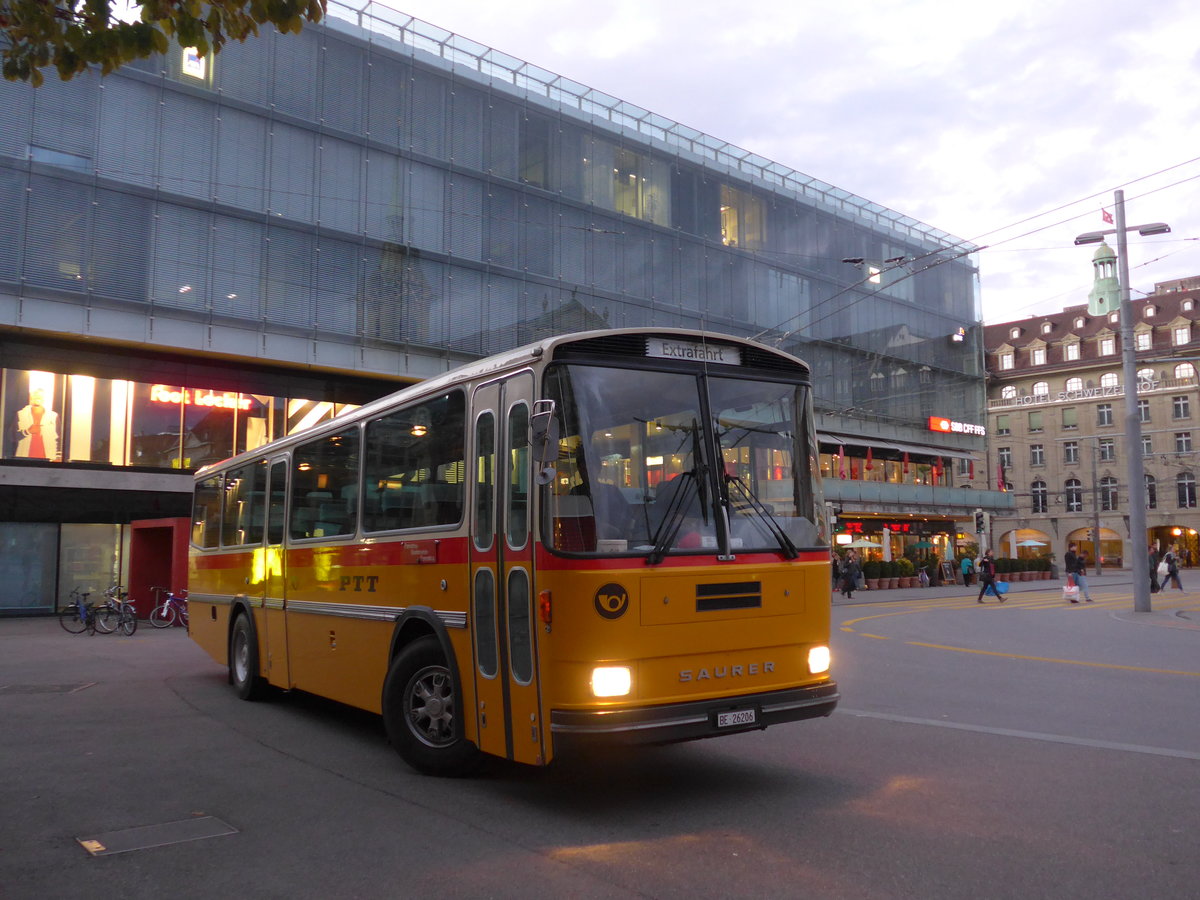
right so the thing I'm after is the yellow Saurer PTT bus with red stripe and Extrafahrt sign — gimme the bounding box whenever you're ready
[188,329,839,774]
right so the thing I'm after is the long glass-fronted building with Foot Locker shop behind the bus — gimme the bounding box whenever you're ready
[0,2,1003,612]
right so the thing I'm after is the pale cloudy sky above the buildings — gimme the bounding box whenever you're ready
[372,0,1200,323]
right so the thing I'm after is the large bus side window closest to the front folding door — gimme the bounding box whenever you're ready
[362,391,466,532]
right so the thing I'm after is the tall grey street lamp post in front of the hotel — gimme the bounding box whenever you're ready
[1075,191,1171,612]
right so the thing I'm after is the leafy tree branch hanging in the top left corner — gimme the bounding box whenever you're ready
[0,0,325,88]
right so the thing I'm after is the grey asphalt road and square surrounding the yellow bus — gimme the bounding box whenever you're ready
[0,582,1200,900]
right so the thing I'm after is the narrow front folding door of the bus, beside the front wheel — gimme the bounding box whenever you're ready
[469,372,545,764]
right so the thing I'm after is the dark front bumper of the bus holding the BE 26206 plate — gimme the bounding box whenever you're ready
[550,682,841,748]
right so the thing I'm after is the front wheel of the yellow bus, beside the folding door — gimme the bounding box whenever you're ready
[383,635,481,776]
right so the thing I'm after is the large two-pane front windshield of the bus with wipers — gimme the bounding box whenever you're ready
[544,365,818,563]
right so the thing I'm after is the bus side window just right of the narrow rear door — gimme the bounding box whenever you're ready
[290,426,359,539]
